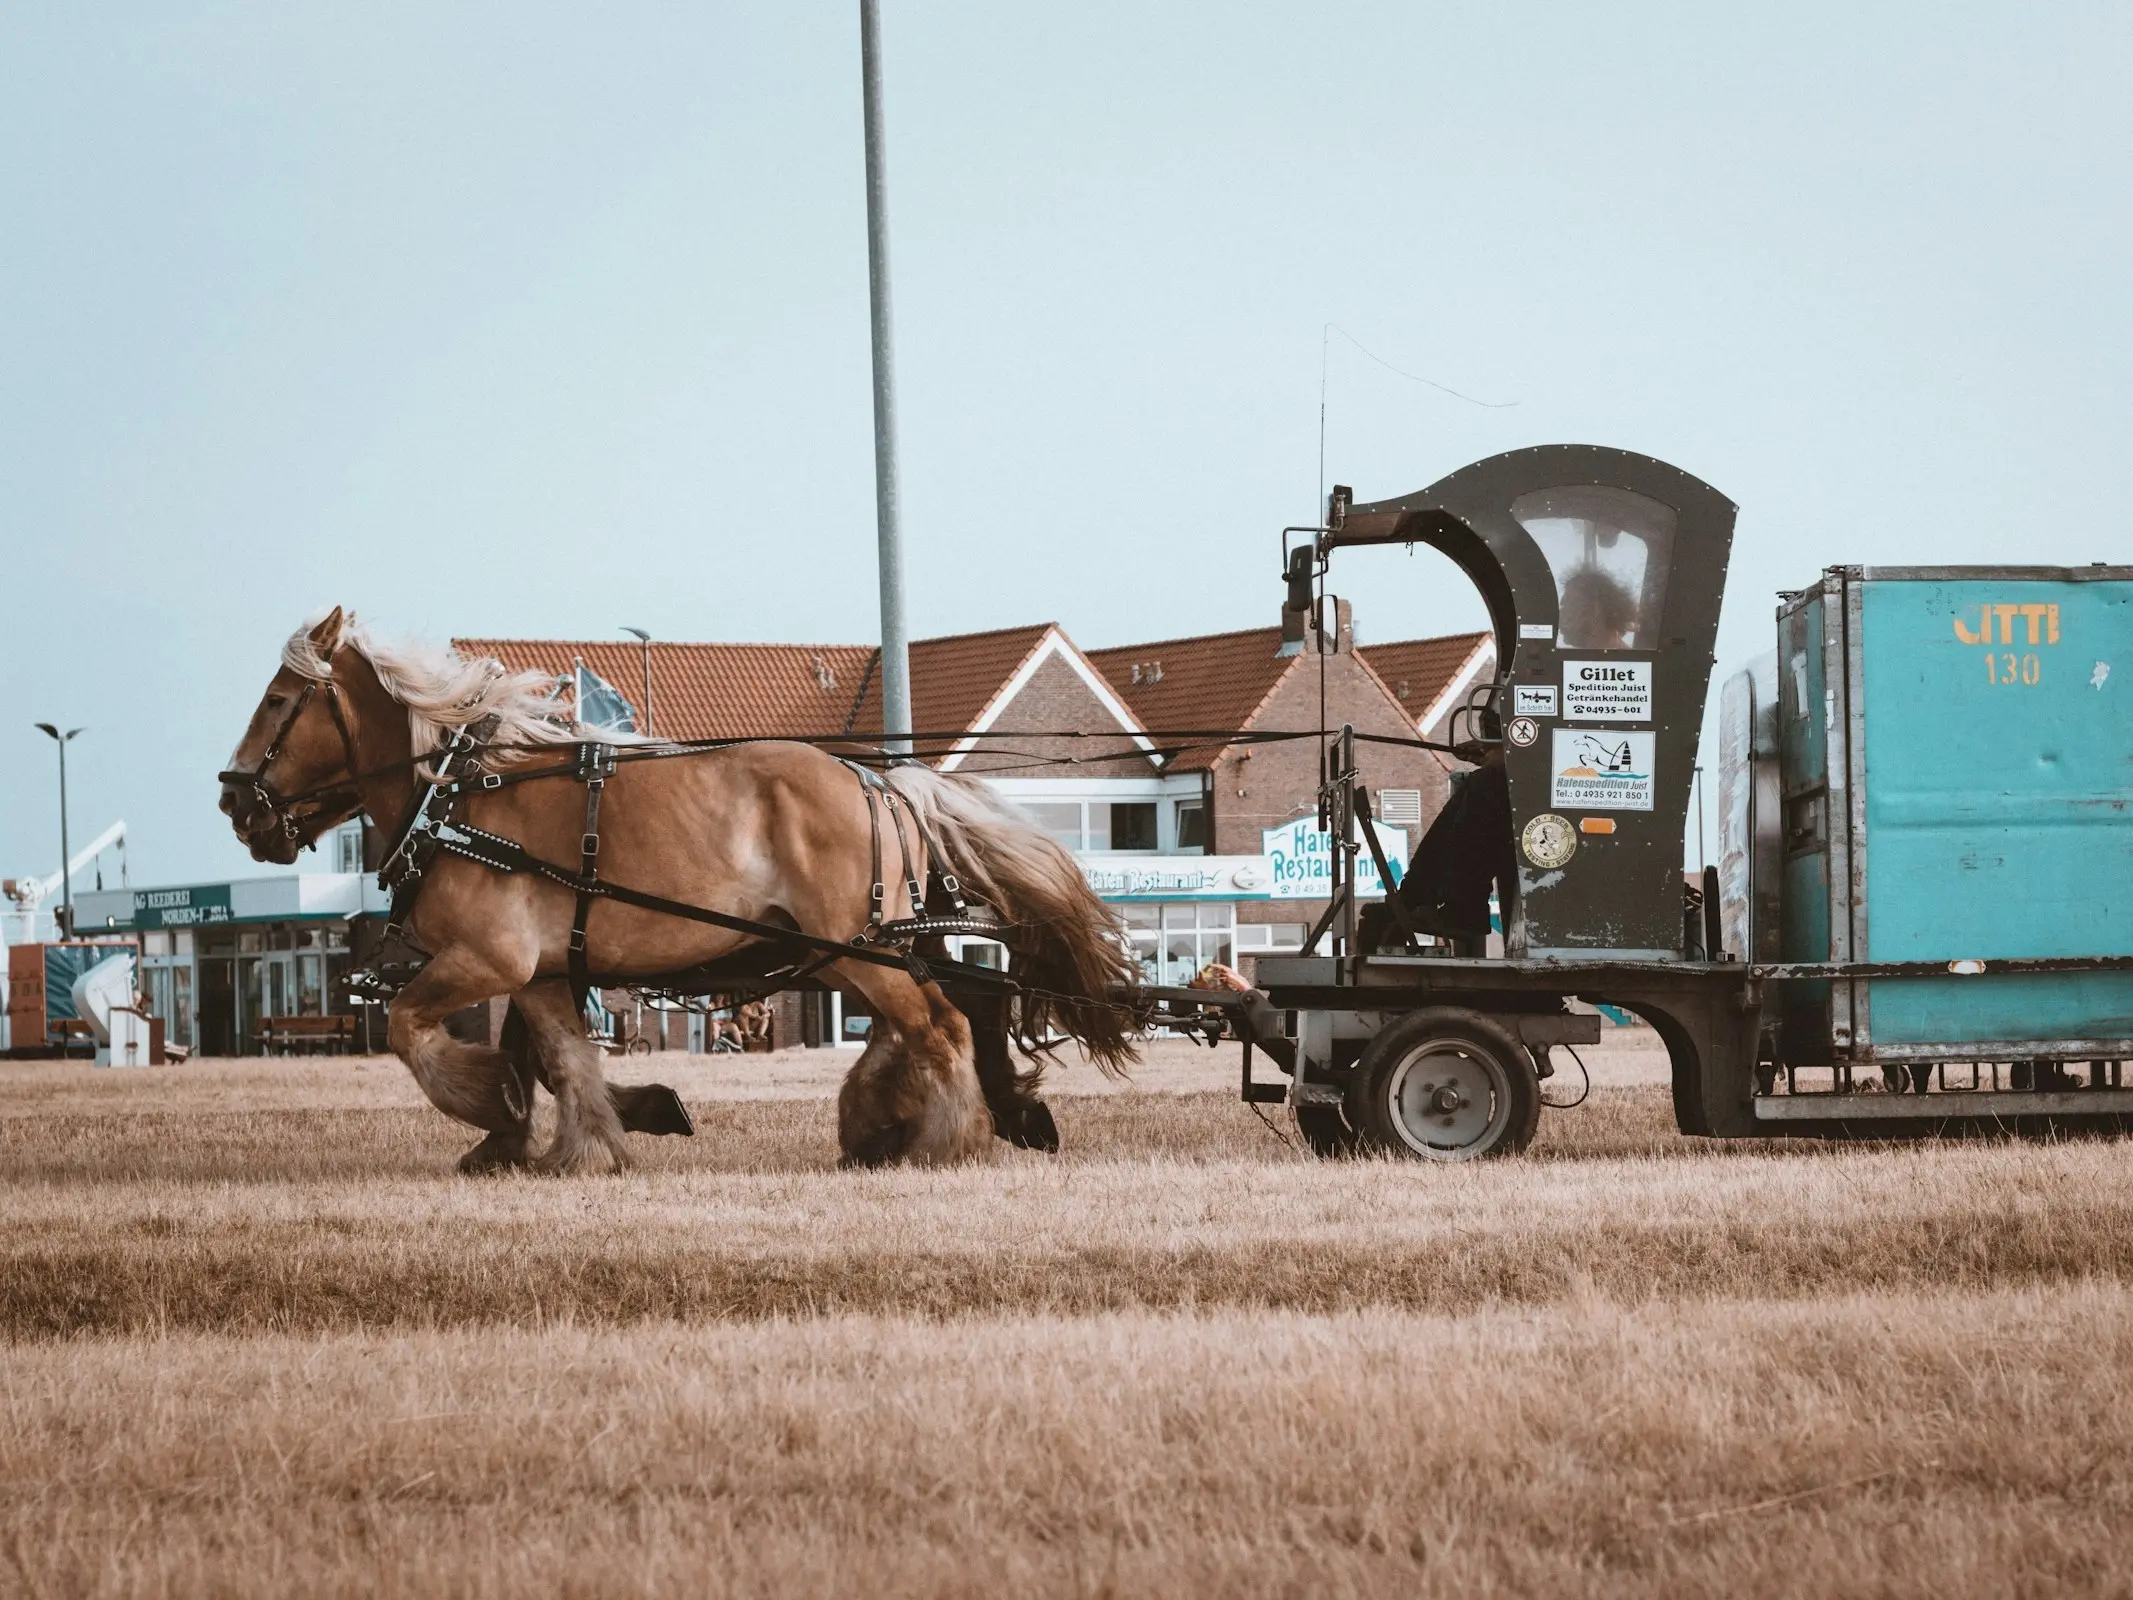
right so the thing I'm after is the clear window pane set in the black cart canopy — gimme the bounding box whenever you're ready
[1510,484,1677,651]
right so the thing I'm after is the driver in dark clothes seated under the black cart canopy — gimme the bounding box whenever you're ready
[1359,710,1519,956]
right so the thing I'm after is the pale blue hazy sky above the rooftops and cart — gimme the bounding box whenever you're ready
[0,0,2133,881]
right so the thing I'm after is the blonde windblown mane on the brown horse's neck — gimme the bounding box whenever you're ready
[282,612,642,766]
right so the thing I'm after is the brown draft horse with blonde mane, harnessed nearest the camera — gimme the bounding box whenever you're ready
[222,608,1135,1171]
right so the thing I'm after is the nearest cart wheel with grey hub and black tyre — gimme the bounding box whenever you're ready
[1357,1007,1540,1161]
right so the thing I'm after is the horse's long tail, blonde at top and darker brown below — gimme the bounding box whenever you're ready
[889,766,1141,1075]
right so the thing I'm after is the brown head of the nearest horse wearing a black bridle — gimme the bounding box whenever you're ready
[222,606,363,866]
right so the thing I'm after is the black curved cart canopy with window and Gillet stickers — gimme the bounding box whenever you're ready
[1318,444,1734,960]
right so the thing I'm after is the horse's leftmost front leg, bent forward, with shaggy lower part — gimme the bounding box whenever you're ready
[386,949,533,1171]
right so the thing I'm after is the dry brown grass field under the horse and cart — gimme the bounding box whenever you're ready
[0,1045,2133,1596]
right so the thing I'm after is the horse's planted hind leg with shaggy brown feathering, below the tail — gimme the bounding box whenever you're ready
[836,962,992,1167]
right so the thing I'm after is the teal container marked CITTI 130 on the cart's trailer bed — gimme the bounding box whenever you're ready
[1753,565,2133,1062]
